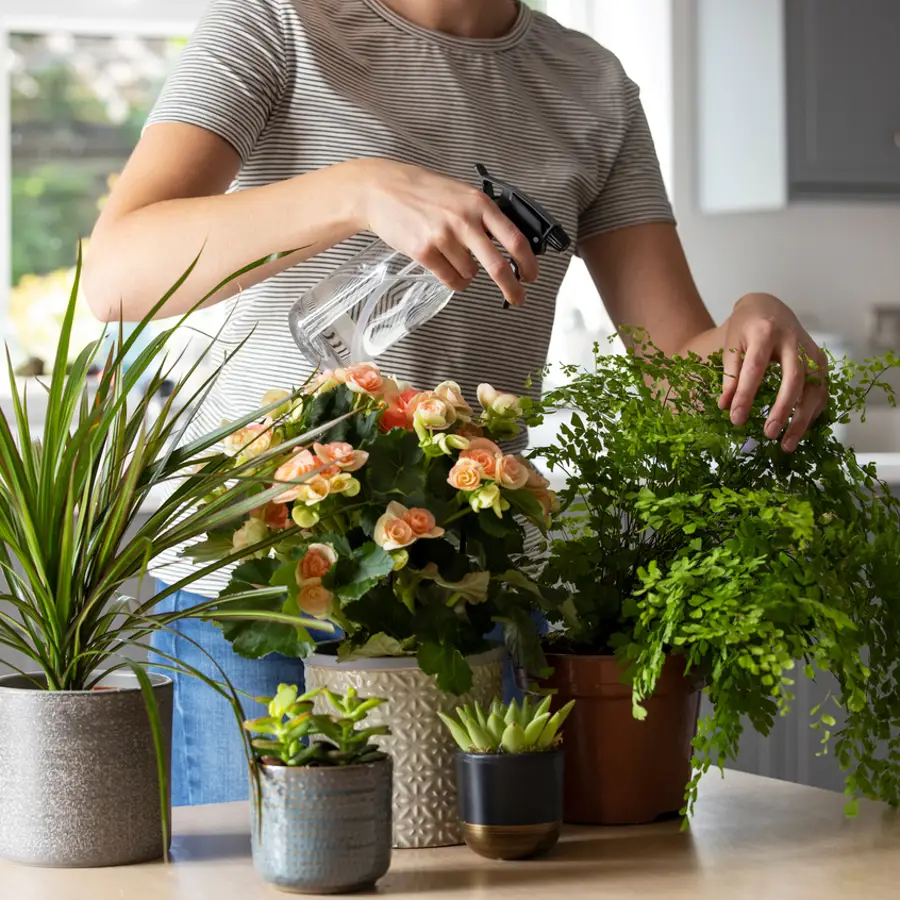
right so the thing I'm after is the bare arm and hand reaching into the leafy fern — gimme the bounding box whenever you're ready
[580,222,828,451]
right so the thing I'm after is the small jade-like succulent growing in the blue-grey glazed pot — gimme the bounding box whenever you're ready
[244,684,390,767]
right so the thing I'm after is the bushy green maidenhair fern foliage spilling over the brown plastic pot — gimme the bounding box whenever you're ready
[532,336,900,813]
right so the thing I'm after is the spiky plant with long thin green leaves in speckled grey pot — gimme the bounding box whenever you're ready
[0,254,348,843]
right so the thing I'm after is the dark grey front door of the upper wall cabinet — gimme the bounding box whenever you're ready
[785,0,900,197]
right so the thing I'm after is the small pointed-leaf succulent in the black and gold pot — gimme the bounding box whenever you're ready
[438,695,575,753]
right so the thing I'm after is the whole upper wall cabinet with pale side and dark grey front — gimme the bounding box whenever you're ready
[693,0,900,213]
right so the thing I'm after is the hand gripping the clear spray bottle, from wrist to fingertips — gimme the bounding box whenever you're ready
[348,159,538,306]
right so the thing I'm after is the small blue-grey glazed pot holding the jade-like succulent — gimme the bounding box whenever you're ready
[251,759,393,894]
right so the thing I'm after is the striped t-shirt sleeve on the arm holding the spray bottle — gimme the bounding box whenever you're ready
[147,0,289,163]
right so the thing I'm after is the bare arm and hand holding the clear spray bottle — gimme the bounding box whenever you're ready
[84,123,537,321]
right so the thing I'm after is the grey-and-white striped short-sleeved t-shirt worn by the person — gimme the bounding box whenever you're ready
[149,0,672,596]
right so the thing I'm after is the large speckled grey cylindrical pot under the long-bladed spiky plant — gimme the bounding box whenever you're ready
[0,672,173,867]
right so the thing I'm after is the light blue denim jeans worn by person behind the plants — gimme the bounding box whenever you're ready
[150,584,518,806]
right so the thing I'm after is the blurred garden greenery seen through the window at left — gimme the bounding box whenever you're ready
[9,34,184,361]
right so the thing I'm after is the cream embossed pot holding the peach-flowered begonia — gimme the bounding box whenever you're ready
[304,648,506,849]
